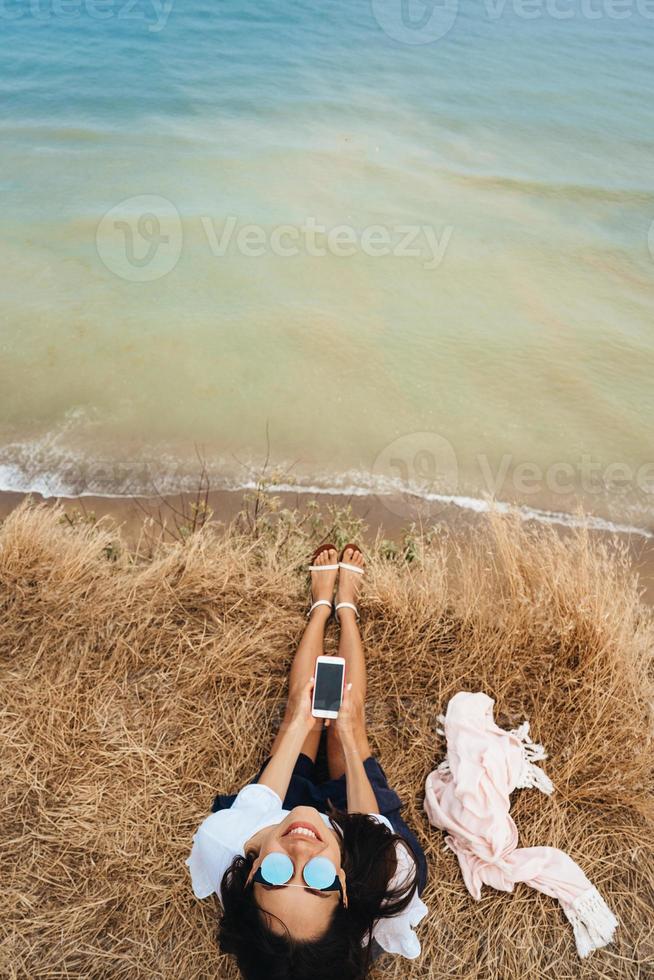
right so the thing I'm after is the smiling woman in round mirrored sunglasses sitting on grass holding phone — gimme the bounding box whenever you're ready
[188,544,427,980]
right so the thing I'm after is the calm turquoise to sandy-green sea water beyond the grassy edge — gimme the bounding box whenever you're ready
[0,0,654,528]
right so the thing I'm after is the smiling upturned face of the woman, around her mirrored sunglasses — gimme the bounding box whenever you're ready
[245,806,347,939]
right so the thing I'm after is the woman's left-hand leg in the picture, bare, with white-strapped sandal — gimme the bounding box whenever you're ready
[271,549,338,762]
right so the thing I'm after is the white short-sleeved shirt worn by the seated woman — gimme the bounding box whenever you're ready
[186,783,427,959]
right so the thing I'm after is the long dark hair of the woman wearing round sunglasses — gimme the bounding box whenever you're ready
[218,810,418,980]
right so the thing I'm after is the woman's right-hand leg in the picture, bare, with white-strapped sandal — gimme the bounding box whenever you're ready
[327,548,370,779]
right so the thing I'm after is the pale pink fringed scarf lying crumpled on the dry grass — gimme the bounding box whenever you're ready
[425,691,618,957]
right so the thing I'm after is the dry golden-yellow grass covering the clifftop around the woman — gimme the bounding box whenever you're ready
[0,507,654,980]
